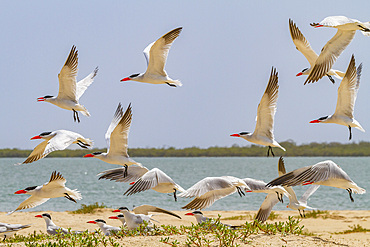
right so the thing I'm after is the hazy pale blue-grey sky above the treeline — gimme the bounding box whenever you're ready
[0,1,370,149]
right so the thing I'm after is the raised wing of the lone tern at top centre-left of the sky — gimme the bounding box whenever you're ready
[144,27,182,76]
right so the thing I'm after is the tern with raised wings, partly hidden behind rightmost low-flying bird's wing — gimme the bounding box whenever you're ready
[278,157,320,217]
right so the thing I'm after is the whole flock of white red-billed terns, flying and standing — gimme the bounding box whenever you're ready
[0,16,370,237]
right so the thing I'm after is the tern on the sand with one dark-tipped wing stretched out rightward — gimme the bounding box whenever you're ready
[113,205,181,230]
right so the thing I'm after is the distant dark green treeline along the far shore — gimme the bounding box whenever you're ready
[0,141,370,157]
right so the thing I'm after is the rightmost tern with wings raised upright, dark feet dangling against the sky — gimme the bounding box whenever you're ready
[310,55,365,140]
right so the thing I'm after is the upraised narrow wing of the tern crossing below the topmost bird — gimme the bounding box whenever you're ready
[289,19,319,66]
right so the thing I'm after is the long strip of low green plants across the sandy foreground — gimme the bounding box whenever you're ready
[3,215,303,247]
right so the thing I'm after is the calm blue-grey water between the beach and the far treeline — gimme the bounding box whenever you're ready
[0,157,370,212]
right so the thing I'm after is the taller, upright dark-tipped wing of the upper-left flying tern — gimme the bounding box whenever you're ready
[58,46,78,103]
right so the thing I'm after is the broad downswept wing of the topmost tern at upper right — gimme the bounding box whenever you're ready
[304,29,356,84]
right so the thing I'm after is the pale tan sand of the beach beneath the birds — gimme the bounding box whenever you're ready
[0,209,370,247]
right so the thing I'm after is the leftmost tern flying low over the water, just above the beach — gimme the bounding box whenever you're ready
[8,171,82,214]
